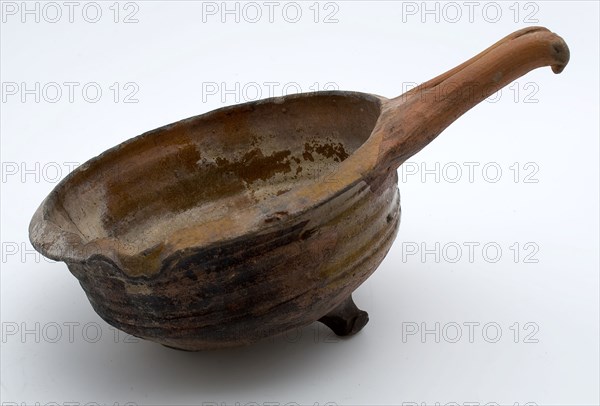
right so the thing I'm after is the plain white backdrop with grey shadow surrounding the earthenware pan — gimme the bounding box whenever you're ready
[1,1,599,405]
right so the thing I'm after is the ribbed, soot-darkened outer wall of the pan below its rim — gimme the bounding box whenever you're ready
[68,171,400,351]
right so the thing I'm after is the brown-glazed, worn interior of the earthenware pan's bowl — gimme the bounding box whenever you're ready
[51,92,380,249]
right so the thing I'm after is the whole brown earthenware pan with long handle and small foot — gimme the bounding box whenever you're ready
[29,27,569,350]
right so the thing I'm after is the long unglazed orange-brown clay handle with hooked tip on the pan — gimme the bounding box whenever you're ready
[378,27,570,170]
